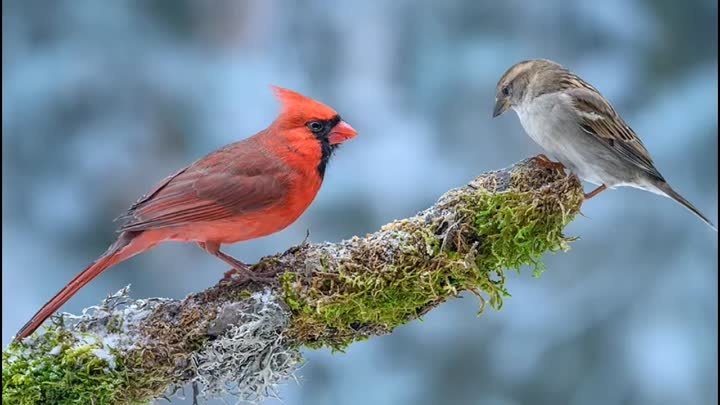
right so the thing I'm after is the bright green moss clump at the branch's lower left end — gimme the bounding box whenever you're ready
[2,328,124,405]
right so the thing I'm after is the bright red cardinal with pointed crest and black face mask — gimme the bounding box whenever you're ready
[16,87,357,340]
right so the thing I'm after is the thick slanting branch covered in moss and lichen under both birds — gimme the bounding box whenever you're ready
[3,160,583,405]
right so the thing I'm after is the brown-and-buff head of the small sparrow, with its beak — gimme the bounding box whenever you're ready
[493,59,565,117]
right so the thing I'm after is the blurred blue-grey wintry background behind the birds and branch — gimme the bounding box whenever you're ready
[2,0,718,405]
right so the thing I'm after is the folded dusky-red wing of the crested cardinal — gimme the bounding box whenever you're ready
[120,143,288,231]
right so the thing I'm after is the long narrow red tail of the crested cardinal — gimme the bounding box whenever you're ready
[15,232,154,341]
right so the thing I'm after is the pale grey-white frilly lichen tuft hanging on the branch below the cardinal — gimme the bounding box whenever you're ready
[192,289,302,403]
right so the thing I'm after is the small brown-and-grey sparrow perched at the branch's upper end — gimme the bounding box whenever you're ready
[493,59,717,231]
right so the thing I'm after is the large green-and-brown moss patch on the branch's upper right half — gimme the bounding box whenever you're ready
[281,170,582,350]
